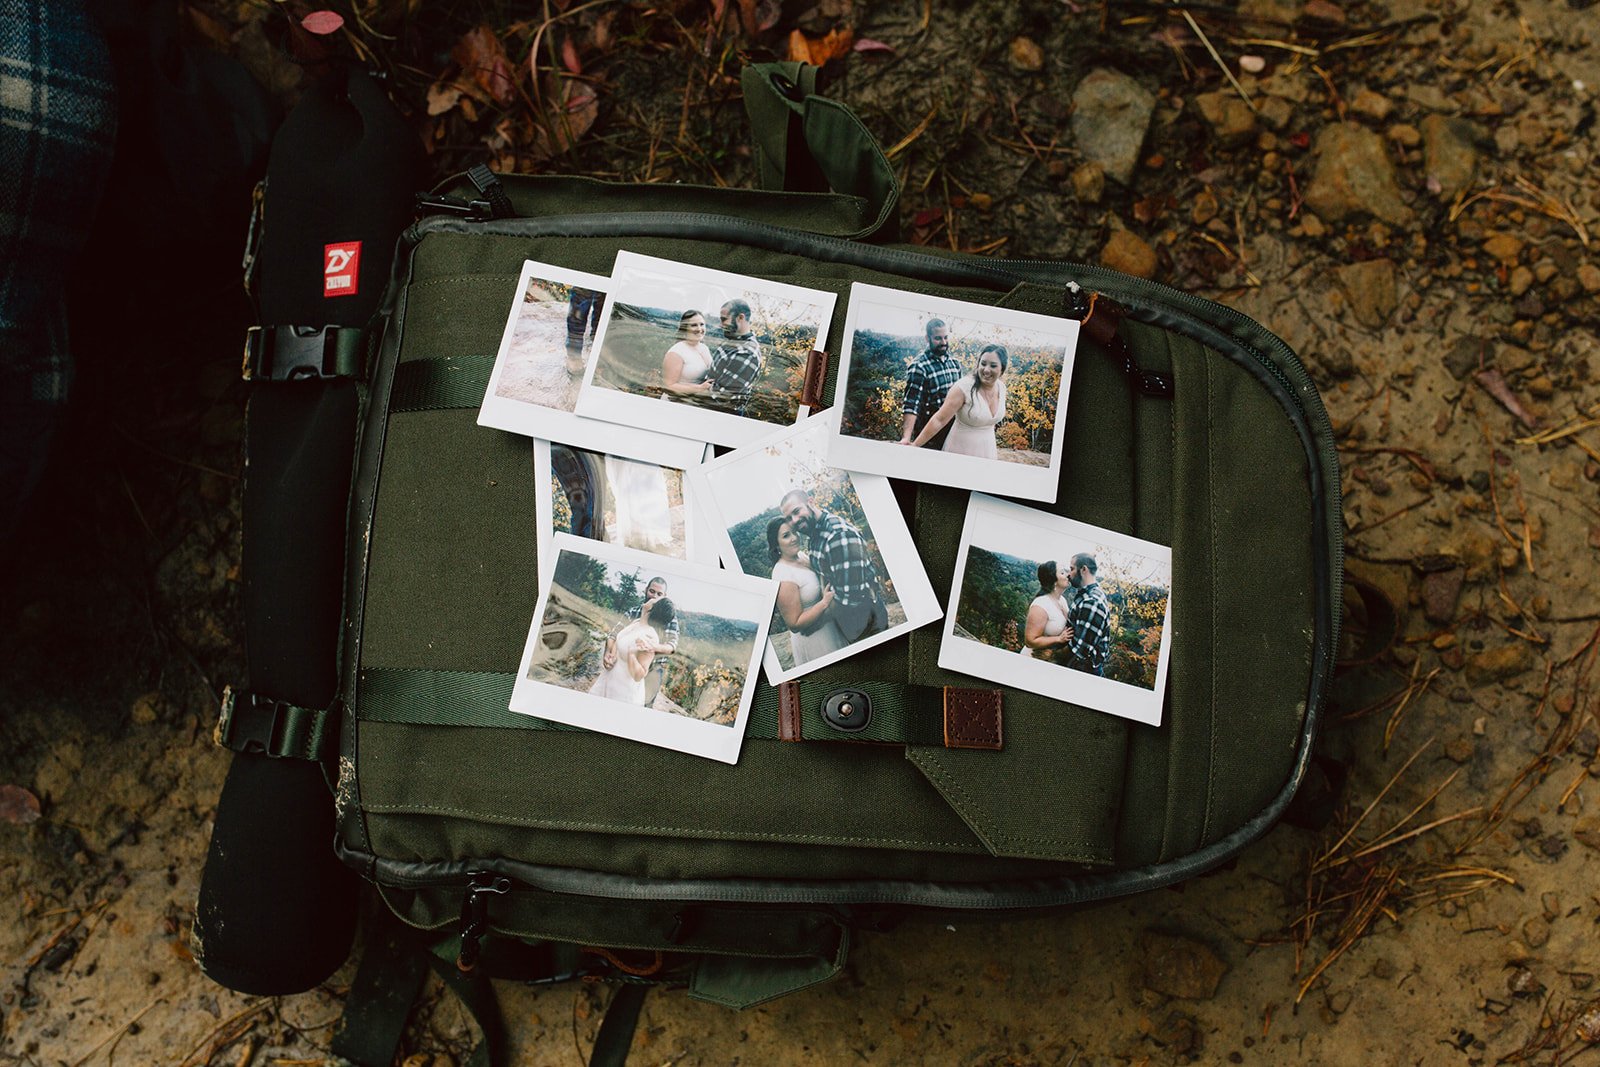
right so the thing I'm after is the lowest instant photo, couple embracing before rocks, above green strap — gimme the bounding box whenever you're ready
[510,533,776,763]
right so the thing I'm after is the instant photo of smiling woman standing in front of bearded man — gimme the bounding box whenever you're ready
[827,283,1078,501]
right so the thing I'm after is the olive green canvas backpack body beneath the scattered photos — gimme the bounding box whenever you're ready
[336,64,1342,1005]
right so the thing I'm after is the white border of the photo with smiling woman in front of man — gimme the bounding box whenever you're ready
[825,282,1080,502]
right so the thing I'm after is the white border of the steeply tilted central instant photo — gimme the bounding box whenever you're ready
[688,410,944,685]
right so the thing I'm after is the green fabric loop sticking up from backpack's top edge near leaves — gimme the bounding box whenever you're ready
[741,62,899,240]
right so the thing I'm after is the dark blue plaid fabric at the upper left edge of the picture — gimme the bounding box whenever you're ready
[0,0,117,533]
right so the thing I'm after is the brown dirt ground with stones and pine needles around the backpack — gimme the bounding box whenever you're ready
[0,0,1600,1067]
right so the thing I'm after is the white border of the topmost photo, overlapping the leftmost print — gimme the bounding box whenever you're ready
[578,251,838,448]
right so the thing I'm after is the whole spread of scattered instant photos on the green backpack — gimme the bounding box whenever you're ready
[478,251,1173,763]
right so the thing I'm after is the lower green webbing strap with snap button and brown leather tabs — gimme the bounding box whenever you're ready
[355,667,985,745]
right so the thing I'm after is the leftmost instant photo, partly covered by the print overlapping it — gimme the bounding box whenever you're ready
[478,261,701,469]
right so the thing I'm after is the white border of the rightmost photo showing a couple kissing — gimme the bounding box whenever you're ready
[939,493,1173,726]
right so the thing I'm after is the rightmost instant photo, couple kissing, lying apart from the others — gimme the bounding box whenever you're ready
[939,493,1173,726]
